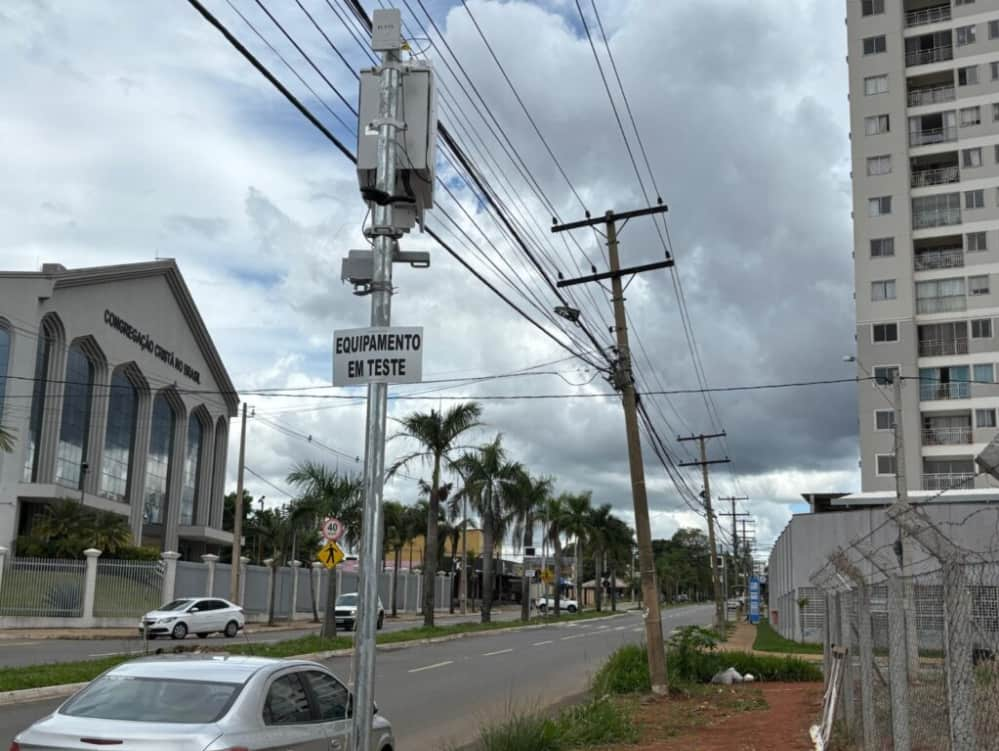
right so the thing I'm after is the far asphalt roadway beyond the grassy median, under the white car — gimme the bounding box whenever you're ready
[0,608,520,667]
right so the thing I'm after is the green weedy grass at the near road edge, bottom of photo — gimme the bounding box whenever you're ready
[475,697,638,751]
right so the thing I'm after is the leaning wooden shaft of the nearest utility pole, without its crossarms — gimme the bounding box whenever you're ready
[604,211,668,696]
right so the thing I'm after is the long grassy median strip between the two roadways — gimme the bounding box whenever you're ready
[0,610,624,691]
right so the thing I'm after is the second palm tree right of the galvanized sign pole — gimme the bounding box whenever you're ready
[458,434,524,623]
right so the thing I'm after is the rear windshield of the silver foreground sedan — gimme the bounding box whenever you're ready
[59,675,243,725]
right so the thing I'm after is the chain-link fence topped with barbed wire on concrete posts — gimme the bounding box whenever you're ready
[811,504,999,751]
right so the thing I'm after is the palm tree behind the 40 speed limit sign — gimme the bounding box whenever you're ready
[287,461,364,638]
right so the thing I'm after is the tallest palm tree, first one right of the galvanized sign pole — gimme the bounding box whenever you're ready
[388,402,482,627]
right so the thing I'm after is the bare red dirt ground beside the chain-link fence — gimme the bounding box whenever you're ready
[629,683,823,751]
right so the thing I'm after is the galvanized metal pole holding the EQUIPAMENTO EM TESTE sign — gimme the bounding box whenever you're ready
[353,36,400,751]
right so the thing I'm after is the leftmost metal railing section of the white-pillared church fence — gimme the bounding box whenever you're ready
[0,558,86,618]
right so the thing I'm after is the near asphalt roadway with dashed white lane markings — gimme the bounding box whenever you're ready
[0,605,712,751]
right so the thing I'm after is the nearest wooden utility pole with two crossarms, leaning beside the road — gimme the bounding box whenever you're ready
[552,204,673,696]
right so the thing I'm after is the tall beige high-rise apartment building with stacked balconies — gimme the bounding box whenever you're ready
[846,0,999,491]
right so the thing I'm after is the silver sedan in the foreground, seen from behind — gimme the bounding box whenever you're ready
[11,655,395,751]
